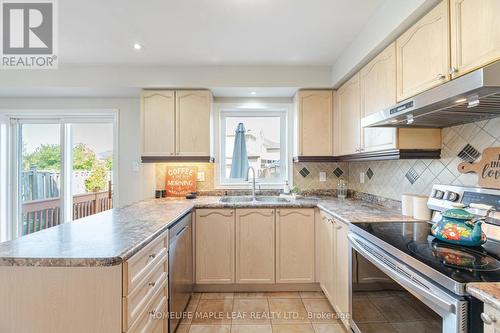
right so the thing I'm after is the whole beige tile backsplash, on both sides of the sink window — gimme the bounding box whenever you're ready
[156,118,500,200]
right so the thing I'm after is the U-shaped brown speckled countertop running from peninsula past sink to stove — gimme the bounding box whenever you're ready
[0,197,412,266]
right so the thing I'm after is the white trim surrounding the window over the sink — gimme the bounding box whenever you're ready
[213,103,293,190]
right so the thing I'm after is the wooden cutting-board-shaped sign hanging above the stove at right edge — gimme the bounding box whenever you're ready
[458,147,500,189]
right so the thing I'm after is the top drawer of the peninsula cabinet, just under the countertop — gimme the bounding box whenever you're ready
[123,231,168,296]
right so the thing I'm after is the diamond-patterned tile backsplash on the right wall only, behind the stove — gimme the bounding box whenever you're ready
[348,118,500,200]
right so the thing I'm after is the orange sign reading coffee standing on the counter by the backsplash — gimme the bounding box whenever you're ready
[165,166,198,197]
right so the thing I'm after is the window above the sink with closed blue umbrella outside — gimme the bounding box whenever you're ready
[218,109,288,188]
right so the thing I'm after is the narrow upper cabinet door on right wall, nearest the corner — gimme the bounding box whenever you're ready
[336,73,361,155]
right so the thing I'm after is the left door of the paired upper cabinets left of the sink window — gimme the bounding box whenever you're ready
[141,90,175,156]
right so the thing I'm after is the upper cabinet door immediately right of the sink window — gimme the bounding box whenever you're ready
[297,90,333,156]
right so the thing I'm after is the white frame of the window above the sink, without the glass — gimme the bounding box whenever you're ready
[214,103,292,190]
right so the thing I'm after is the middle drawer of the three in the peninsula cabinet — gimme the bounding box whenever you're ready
[123,257,168,329]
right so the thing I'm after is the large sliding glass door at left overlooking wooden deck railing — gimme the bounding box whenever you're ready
[2,112,116,237]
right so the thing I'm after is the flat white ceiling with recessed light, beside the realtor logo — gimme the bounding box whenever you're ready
[58,0,384,66]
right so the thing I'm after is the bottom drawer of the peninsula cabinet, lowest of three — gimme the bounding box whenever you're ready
[127,282,168,333]
